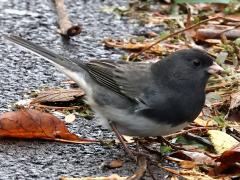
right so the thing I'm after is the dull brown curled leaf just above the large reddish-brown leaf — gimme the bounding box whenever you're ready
[31,89,85,104]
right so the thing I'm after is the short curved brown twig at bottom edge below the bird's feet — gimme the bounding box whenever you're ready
[127,156,147,180]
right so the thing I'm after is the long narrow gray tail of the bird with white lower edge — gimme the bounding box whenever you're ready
[5,35,82,71]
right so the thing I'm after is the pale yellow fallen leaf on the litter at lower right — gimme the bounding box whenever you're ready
[208,130,239,154]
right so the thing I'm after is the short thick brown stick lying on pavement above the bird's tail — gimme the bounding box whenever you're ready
[54,0,81,38]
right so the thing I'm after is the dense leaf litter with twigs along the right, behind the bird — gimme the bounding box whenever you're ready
[100,1,240,179]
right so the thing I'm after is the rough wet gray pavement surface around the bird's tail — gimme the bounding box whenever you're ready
[0,0,169,180]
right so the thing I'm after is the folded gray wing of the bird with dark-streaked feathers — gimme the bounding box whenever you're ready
[86,60,152,100]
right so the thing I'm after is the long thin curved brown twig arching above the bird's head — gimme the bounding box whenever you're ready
[133,16,239,59]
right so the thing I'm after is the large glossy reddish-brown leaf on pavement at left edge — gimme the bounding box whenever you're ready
[0,109,94,143]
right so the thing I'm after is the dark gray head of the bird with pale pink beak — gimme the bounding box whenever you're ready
[152,49,222,88]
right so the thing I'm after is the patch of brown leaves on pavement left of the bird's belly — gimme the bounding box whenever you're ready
[0,82,98,144]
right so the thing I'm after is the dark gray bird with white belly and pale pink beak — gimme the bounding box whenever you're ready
[6,36,223,137]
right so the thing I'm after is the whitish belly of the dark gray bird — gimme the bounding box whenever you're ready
[89,105,189,137]
